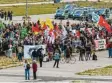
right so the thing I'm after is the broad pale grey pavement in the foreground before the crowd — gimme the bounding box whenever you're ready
[0,51,112,83]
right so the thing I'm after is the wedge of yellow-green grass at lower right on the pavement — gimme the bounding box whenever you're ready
[77,66,112,76]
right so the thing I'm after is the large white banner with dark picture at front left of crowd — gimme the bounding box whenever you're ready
[24,45,46,59]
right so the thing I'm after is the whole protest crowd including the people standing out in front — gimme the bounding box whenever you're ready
[0,20,112,79]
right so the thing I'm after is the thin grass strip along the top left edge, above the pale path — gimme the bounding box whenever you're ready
[0,0,51,4]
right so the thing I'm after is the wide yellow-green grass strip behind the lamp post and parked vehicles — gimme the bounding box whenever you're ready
[0,2,112,16]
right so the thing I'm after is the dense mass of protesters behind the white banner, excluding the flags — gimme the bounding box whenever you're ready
[0,21,112,61]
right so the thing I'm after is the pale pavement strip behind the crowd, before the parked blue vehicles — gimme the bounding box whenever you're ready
[1,14,82,25]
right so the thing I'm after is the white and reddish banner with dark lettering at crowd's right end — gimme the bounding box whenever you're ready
[95,39,106,50]
